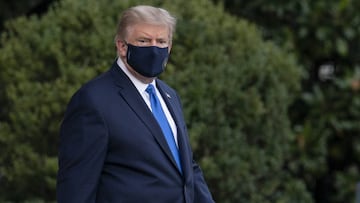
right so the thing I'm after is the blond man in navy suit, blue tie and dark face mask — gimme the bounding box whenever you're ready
[57,6,214,203]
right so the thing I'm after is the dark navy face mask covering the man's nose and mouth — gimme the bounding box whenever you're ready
[126,43,169,77]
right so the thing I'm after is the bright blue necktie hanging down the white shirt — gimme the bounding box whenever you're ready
[146,84,182,172]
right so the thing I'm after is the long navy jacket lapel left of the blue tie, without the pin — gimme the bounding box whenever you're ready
[111,63,180,171]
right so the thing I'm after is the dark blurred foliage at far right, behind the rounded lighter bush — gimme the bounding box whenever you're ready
[214,0,360,202]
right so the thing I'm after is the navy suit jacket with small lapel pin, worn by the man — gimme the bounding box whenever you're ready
[57,63,213,203]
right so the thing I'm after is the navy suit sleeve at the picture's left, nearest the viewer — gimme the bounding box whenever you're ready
[57,89,108,203]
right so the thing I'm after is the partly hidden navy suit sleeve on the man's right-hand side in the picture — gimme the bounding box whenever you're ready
[193,161,215,203]
